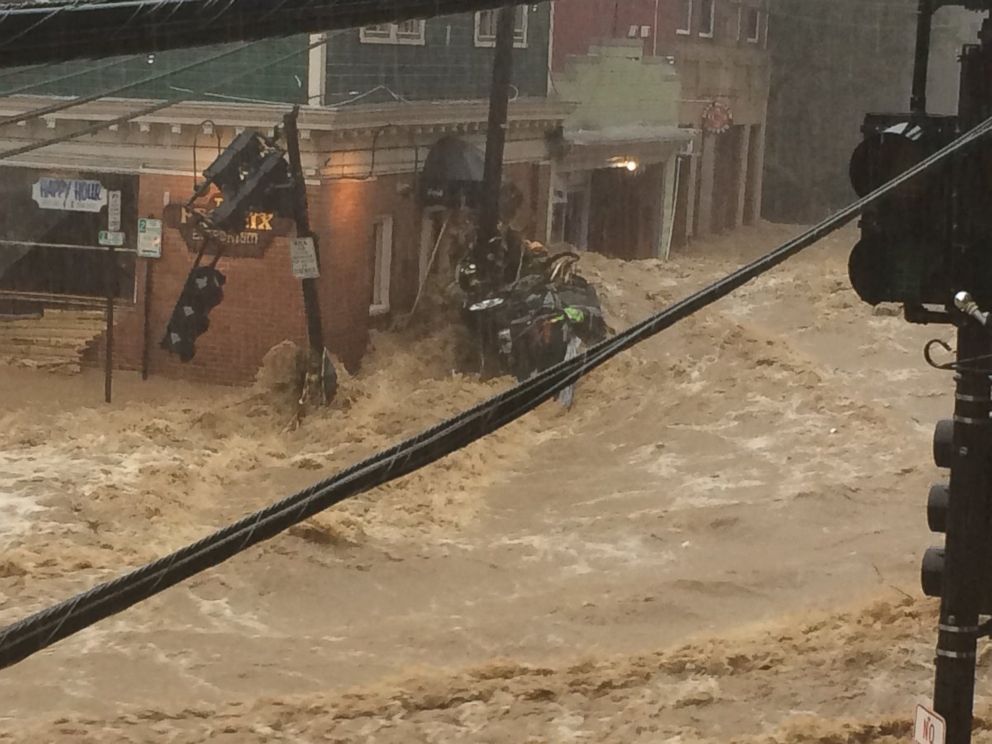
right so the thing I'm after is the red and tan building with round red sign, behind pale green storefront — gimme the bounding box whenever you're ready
[552,0,769,246]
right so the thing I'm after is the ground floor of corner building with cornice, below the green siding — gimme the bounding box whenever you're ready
[0,98,567,383]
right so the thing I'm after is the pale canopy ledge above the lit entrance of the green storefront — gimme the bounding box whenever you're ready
[558,125,695,172]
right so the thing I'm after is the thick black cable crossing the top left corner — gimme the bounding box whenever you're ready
[0,0,544,67]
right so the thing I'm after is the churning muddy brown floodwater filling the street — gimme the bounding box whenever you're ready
[0,225,992,744]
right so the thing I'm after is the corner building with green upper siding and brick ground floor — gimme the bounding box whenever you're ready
[0,4,571,383]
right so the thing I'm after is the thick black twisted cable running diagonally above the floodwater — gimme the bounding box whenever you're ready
[0,112,992,668]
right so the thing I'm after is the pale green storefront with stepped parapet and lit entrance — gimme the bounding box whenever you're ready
[549,39,692,259]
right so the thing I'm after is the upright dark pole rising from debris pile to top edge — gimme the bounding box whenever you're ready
[476,5,516,257]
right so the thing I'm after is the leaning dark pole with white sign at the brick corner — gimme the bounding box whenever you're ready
[283,106,337,412]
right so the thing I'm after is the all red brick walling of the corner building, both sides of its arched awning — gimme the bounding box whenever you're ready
[87,163,550,384]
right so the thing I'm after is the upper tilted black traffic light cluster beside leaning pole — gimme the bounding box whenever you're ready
[190,131,292,232]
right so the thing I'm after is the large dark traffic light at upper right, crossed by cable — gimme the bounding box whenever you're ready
[848,114,956,308]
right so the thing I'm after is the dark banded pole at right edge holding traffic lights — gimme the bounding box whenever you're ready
[928,18,992,744]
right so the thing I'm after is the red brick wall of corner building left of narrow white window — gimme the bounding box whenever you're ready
[89,176,368,384]
